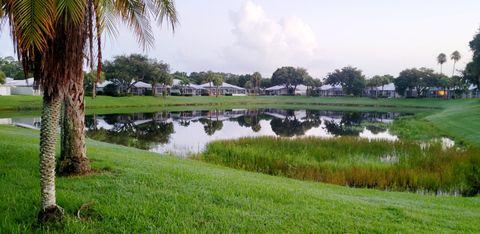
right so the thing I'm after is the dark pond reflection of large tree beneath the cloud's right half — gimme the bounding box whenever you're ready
[270,110,321,137]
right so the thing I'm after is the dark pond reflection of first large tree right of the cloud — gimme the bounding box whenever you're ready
[325,112,362,136]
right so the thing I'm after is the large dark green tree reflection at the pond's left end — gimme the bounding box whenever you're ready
[87,113,174,149]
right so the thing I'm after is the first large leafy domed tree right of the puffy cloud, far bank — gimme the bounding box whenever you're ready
[325,66,366,96]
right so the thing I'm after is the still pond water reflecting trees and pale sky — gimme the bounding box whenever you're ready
[86,109,401,156]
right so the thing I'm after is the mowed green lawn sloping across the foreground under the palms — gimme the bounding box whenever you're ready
[0,126,480,233]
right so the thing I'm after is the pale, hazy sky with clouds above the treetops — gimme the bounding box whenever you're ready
[0,0,480,78]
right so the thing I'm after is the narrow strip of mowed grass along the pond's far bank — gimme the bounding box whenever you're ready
[0,96,456,111]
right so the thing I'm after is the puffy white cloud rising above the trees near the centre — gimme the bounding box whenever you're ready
[223,1,319,74]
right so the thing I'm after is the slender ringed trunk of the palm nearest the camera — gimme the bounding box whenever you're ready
[39,94,63,221]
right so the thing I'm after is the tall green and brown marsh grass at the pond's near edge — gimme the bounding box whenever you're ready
[200,137,480,195]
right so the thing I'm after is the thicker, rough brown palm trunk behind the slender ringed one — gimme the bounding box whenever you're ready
[59,76,91,175]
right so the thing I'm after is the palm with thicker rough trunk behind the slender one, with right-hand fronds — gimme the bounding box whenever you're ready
[59,0,177,175]
